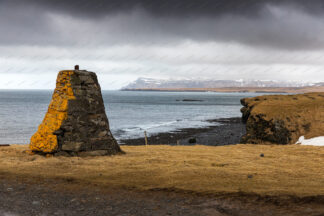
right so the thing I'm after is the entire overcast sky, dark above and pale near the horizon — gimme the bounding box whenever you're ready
[0,0,324,89]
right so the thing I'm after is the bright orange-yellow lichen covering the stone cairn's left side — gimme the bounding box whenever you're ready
[29,70,75,153]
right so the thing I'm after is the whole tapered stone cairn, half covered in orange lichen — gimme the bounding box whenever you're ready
[29,65,122,156]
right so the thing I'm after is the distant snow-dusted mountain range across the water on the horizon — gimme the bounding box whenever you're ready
[122,78,324,90]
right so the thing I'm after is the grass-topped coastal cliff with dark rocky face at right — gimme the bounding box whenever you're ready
[241,93,324,144]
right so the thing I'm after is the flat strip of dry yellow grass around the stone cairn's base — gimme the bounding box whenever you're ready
[0,145,324,196]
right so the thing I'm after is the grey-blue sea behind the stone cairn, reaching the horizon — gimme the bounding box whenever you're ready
[0,90,261,144]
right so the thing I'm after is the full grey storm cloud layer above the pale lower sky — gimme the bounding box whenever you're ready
[0,0,324,49]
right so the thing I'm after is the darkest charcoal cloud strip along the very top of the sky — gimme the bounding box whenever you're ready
[2,0,324,17]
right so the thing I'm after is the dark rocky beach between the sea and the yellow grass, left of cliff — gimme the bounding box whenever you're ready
[119,118,246,146]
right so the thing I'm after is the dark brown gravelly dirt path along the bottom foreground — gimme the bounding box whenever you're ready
[0,179,324,216]
